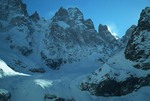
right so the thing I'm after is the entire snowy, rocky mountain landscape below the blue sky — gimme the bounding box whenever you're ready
[0,0,150,101]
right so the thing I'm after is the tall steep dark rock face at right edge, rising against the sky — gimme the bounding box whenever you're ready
[124,7,150,70]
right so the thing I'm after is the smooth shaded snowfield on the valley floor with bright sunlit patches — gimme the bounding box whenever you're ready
[0,58,150,101]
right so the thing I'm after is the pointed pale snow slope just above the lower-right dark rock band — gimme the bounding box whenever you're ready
[83,50,150,83]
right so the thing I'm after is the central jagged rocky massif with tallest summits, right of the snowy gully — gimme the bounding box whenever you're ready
[41,7,117,69]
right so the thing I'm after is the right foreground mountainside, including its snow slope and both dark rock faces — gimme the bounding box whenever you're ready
[80,7,150,97]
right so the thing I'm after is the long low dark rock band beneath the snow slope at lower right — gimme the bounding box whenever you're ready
[80,75,150,97]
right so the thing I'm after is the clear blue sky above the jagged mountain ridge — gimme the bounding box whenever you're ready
[22,0,150,37]
